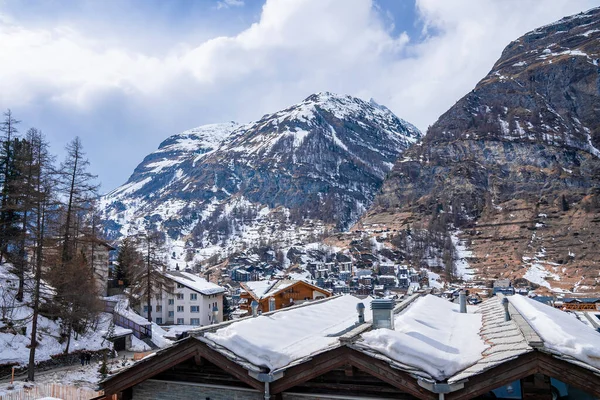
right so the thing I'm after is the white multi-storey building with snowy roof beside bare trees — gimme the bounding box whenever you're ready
[140,271,225,326]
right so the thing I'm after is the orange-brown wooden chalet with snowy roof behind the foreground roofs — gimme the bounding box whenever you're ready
[240,279,331,312]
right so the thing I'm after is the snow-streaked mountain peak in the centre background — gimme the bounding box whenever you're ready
[100,93,421,265]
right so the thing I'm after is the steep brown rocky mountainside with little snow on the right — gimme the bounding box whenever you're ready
[354,8,600,292]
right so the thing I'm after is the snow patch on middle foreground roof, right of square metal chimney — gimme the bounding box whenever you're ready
[362,295,488,380]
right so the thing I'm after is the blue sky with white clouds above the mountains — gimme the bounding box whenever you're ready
[0,0,600,192]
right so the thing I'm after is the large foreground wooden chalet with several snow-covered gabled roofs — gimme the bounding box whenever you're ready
[100,295,600,400]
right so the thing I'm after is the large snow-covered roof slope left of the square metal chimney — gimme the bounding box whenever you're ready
[199,295,372,371]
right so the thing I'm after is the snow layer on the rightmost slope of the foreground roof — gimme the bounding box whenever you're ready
[507,296,600,368]
